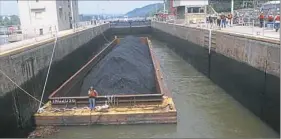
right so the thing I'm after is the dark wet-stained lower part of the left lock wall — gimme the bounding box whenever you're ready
[0,32,112,137]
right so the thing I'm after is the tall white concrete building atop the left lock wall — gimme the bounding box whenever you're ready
[18,0,79,37]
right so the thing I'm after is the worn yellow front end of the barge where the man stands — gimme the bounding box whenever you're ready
[35,98,177,126]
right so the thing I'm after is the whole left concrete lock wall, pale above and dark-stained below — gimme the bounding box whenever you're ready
[0,24,109,137]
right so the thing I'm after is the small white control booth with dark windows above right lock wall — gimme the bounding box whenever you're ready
[173,0,209,24]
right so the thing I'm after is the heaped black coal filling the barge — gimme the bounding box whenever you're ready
[81,36,156,96]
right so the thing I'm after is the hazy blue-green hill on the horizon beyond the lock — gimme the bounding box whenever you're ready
[125,3,164,17]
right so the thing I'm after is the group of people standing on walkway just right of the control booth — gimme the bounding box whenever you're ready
[206,13,233,28]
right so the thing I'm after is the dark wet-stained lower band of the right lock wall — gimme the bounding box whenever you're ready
[153,29,280,132]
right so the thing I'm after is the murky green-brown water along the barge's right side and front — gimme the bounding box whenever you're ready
[47,39,279,138]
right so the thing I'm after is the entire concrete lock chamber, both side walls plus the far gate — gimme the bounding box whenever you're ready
[0,22,280,136]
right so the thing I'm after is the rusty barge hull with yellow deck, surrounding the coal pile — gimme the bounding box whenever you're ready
[34,37,177,126]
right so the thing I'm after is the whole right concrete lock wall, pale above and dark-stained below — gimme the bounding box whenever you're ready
[152,22,280,132]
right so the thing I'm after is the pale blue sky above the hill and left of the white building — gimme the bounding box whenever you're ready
[0,0,163,15]
